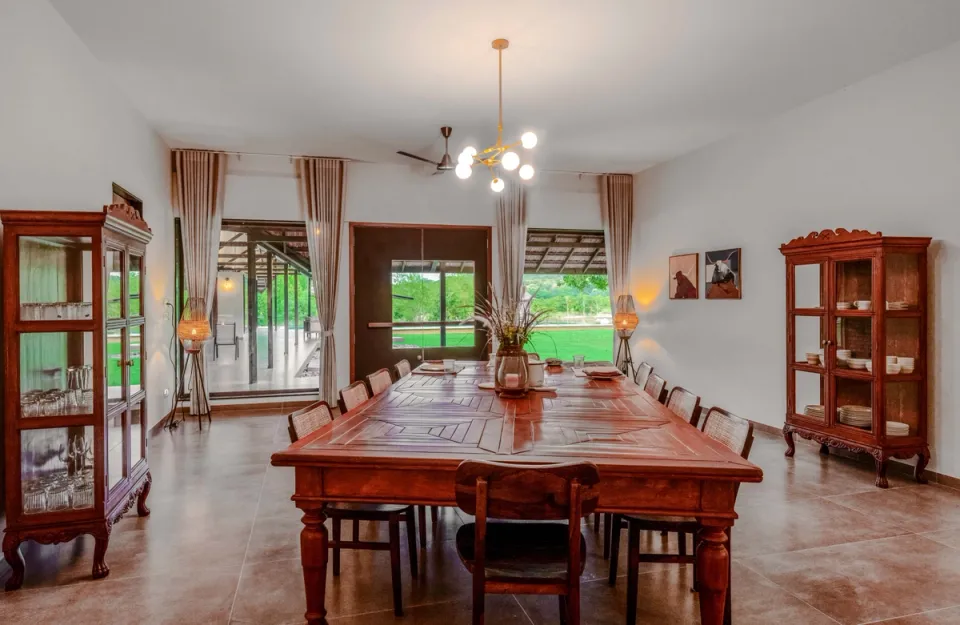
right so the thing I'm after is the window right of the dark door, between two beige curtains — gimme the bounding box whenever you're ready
[523,229,613,360]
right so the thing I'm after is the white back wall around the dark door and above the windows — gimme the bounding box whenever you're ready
[224,157,602,386]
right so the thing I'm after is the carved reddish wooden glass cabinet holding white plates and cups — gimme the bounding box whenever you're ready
[780,229,930,488]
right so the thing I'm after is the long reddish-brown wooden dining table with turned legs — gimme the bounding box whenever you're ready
[272,362,763,625]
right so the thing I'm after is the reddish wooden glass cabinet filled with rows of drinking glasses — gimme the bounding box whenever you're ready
[0,204,152,590]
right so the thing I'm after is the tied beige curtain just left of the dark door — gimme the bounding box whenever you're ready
[294,158,345,405]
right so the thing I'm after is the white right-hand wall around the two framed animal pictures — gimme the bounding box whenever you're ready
[632,44,960,476]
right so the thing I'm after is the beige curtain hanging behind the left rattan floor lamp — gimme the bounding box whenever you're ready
[172,150,227,414]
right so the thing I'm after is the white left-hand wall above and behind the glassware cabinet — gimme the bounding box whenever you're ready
[0,0,175,425]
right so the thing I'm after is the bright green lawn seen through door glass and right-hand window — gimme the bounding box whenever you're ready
[393,326,613,360]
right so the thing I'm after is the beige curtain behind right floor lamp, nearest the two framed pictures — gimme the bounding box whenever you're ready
[600,174,633,366]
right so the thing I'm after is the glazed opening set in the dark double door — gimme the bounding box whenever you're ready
[391,260,476,349]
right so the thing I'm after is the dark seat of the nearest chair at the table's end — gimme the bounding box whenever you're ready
[457,522,587,580]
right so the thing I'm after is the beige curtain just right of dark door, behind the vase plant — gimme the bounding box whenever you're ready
[497,180,527,306]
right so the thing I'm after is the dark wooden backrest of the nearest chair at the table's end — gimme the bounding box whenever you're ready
[455,460,600,525]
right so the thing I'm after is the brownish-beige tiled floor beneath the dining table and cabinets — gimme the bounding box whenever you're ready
[0,417,960,625]
